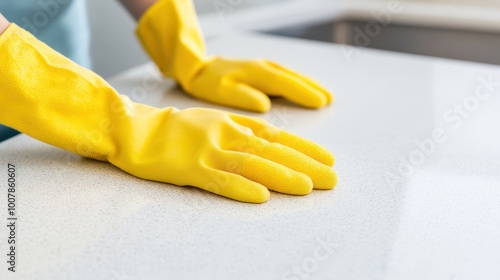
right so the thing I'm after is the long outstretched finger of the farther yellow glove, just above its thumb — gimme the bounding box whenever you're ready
[235,62,327,108]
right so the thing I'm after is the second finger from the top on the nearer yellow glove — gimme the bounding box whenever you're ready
[233,137,337,189]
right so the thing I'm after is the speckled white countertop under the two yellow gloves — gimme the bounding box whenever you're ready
[0,34,500,280]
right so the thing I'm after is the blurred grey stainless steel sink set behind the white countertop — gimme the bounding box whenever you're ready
[266,20,500,65]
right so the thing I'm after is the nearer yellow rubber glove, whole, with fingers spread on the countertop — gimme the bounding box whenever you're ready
[0,24,337,203]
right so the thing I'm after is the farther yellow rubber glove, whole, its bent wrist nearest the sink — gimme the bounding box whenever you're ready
[137,0,332,112]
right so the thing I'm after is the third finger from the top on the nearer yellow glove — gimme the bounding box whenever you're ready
[217,151,313,195]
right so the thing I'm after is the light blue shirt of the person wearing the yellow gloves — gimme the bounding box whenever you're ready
[0,0,91,141]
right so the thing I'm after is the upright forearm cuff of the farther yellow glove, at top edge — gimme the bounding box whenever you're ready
[136,0,205,92]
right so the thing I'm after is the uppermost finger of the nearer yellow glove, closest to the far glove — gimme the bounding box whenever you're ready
[229,114,335,166]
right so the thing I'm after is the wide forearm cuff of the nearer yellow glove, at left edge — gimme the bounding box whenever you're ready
[0,24,154,161]
